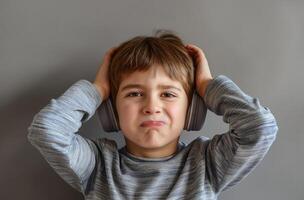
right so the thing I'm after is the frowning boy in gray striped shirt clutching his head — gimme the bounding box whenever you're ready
[28,30,278,200]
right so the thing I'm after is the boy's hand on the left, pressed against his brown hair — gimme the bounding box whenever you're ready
[93,47,117,100]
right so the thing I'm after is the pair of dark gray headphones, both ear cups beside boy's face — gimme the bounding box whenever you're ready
[97,90,207,132]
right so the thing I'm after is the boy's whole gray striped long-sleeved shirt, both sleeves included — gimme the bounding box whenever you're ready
[28,75,278,200]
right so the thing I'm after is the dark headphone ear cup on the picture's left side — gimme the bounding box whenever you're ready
[97,97,120,132]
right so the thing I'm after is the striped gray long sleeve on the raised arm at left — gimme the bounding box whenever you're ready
[27,79,102,193]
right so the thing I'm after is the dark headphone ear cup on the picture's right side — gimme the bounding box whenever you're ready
[184,90,207,131]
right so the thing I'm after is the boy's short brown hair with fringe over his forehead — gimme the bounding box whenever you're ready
[109,29,194,108]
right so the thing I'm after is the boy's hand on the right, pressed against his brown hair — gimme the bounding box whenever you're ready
[185,44,213,98]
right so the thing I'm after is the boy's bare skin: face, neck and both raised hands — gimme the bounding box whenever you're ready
[93,44,213,158]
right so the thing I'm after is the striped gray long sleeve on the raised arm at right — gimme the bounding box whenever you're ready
[204,75,278,193]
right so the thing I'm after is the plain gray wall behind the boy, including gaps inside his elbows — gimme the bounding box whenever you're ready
[0,0,304,200]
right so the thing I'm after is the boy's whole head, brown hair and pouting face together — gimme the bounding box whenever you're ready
[109,31,194,157]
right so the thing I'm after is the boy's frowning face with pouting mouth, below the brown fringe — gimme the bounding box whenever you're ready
[116,65,188,158]
